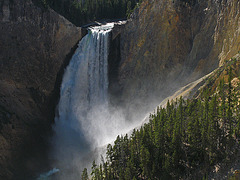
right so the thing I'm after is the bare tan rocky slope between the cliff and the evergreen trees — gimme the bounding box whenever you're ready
[142,54,240,125]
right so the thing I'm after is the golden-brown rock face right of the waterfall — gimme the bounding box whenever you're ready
[115,0,240,118]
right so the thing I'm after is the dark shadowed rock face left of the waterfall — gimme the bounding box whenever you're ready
[0,0,81,179]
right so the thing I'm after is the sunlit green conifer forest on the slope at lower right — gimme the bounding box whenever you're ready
[82,60,240,180]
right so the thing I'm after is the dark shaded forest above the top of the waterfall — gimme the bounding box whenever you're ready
[34,0,141,26]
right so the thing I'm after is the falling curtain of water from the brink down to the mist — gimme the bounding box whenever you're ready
[56,23,114,146]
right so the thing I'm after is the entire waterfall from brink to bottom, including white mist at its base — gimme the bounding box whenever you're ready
[40,23,130,180]
